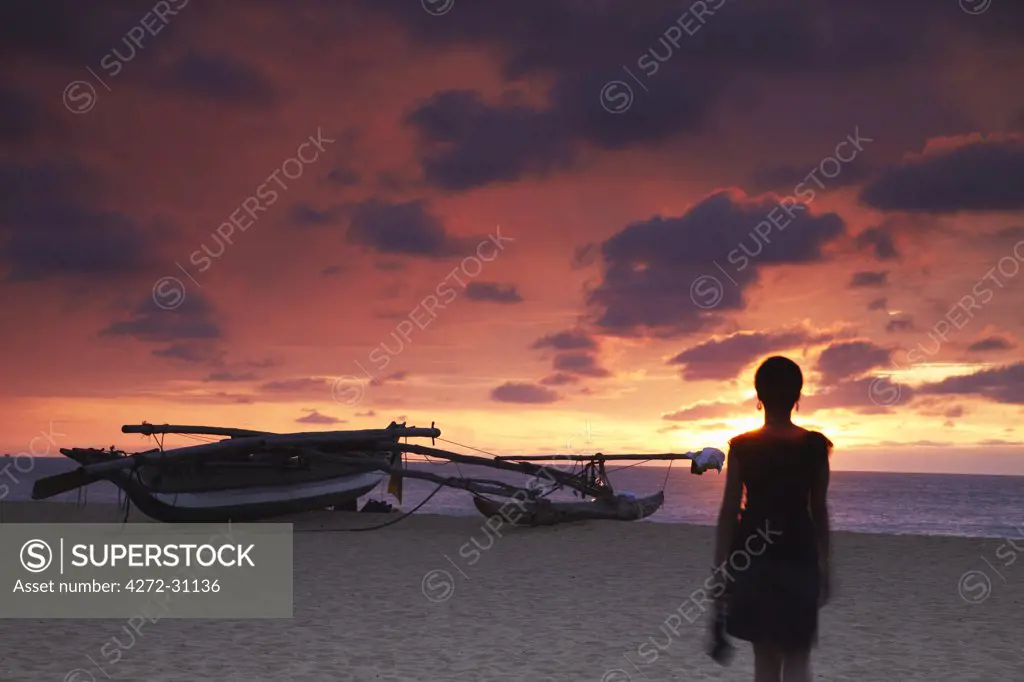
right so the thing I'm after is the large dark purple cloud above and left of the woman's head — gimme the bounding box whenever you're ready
[589,191,846,336]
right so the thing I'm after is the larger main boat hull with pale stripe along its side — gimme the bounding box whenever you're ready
[58,450,387,523]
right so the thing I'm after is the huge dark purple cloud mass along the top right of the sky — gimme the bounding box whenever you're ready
[375,0,1019,189]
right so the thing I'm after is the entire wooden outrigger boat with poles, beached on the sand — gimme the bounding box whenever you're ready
[32,422,725,525]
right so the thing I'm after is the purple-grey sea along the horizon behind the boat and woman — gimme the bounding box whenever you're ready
[0,457,1024,538]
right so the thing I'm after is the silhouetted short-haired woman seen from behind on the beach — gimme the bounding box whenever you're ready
[715,356,831,682]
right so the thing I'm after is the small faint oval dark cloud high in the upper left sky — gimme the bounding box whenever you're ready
[154,51,278,108]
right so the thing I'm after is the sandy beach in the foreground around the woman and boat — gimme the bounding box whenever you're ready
[0,503,1024,682]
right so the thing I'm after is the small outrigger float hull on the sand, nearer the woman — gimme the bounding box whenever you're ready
[473,493,665,526]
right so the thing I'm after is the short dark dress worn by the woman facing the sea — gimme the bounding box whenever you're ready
[725,431,831,650]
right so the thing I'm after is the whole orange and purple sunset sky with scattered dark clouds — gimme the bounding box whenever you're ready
[0,0,1024,474]
